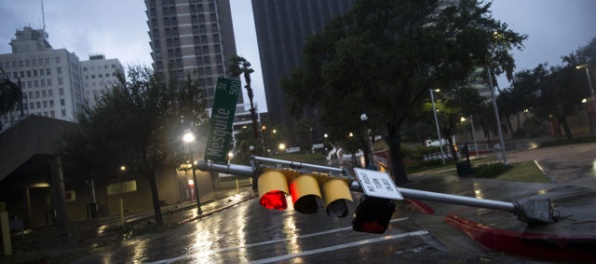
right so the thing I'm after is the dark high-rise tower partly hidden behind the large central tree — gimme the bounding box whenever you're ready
[252,0,355,144]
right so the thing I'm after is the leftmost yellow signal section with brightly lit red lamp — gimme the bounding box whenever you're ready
[258,170,289,210]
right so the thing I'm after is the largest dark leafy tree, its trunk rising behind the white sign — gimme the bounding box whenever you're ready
[282,0,525,184]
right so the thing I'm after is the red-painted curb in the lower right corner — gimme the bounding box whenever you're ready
[445,215,596,261]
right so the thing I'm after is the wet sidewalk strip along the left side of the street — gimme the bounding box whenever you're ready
[5,187,255,255]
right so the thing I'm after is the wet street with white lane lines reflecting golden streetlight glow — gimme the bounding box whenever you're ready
[84,192,432,263]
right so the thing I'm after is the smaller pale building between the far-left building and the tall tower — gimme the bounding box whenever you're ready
[81,55,124,107]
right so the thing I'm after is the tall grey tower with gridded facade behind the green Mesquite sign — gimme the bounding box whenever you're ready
[145,0,242,107]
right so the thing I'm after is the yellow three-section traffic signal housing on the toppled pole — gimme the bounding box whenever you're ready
[257,168,353,217]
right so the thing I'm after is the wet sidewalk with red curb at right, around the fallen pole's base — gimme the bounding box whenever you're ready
[404,144,596,262]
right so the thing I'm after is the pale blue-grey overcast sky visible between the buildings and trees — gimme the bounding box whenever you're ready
[0,0,596,110]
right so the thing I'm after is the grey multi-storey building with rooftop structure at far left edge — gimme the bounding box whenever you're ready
[0,27,83,128]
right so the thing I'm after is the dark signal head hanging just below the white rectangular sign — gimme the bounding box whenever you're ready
[352,194,395,234]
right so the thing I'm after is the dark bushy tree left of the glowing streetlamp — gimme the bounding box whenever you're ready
[60,67,206,224]
